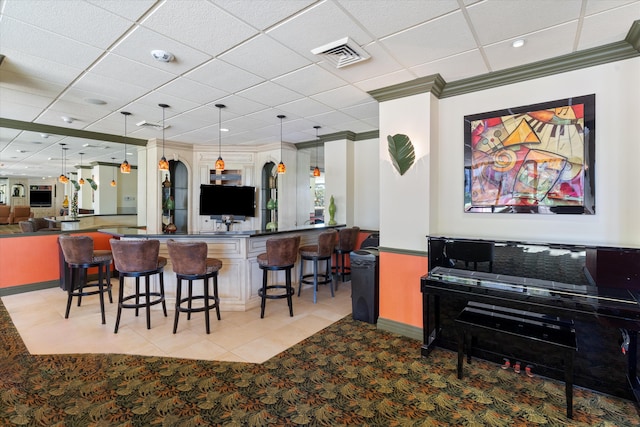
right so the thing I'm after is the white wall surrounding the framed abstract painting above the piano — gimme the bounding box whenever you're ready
[432,58,640,247]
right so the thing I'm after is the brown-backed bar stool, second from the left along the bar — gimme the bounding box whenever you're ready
[109,239,167,334]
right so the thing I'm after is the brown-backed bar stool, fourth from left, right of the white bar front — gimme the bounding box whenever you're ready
[257,236,300,319]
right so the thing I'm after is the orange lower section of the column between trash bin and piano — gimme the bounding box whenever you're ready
[378,252,427,328]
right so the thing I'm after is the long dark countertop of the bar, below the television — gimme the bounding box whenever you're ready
[98,224,346,239]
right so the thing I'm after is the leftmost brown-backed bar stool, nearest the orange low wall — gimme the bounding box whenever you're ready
[58,234,113,325]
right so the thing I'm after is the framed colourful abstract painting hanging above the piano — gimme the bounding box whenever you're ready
[464,94,596,214]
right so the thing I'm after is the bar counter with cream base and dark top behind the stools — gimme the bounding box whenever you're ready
[98,224,345,311]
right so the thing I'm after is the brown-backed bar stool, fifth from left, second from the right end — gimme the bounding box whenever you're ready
[298,230,338,304]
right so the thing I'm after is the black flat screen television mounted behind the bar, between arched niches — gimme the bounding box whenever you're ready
[200,184,256,217]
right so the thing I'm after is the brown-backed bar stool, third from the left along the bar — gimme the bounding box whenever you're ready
[167,239,222,334]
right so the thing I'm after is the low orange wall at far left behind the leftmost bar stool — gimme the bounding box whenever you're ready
[0,232,111,288]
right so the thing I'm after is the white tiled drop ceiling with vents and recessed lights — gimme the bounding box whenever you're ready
[0,0,640,176]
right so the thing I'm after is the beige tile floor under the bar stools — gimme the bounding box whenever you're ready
[2,280,351,363]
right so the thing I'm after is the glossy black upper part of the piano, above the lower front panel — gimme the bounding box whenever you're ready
[428,236,640,306]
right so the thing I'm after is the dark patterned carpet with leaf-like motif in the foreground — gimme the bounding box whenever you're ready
[0,303,640,427]
